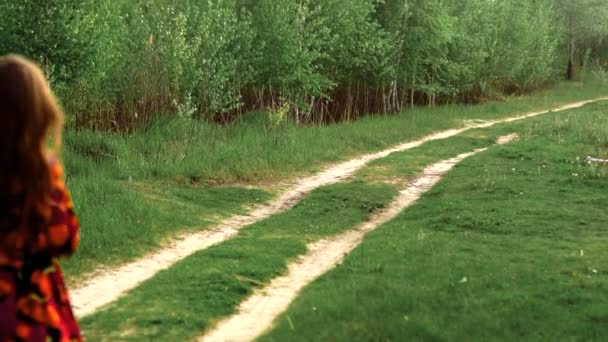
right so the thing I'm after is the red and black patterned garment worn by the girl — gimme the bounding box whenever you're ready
[0,163,81,342]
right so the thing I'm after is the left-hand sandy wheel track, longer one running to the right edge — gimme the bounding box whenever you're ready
[70,97,608,317]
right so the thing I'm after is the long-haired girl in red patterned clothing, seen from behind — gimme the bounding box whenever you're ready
[0,56,81,342]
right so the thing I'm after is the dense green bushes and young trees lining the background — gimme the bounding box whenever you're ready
[0,0,608,129]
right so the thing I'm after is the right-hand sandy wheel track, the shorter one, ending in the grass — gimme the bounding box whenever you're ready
[200,135,517,342]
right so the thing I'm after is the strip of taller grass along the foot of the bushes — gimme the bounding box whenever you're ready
[65,79,608,184]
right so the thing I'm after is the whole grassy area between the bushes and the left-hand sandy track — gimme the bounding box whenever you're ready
[64,78,604,282]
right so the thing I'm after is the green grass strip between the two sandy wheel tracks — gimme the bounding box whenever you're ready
[81,183,396,341]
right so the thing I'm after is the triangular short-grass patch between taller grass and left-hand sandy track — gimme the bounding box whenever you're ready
[64,178,270,281]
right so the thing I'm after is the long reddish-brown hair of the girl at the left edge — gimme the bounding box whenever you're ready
[0,55,64,238]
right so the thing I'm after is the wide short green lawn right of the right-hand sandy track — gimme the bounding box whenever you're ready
[260,103,608,341]
